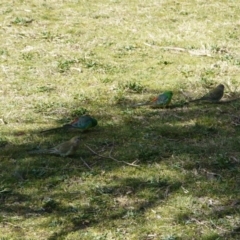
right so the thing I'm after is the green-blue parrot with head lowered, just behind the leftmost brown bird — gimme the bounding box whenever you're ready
[40,115,98,133]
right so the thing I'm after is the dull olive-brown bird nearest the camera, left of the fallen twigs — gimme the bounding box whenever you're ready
[29,136,80,157]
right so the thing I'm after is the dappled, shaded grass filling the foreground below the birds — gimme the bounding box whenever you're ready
[1,104,239,239]
